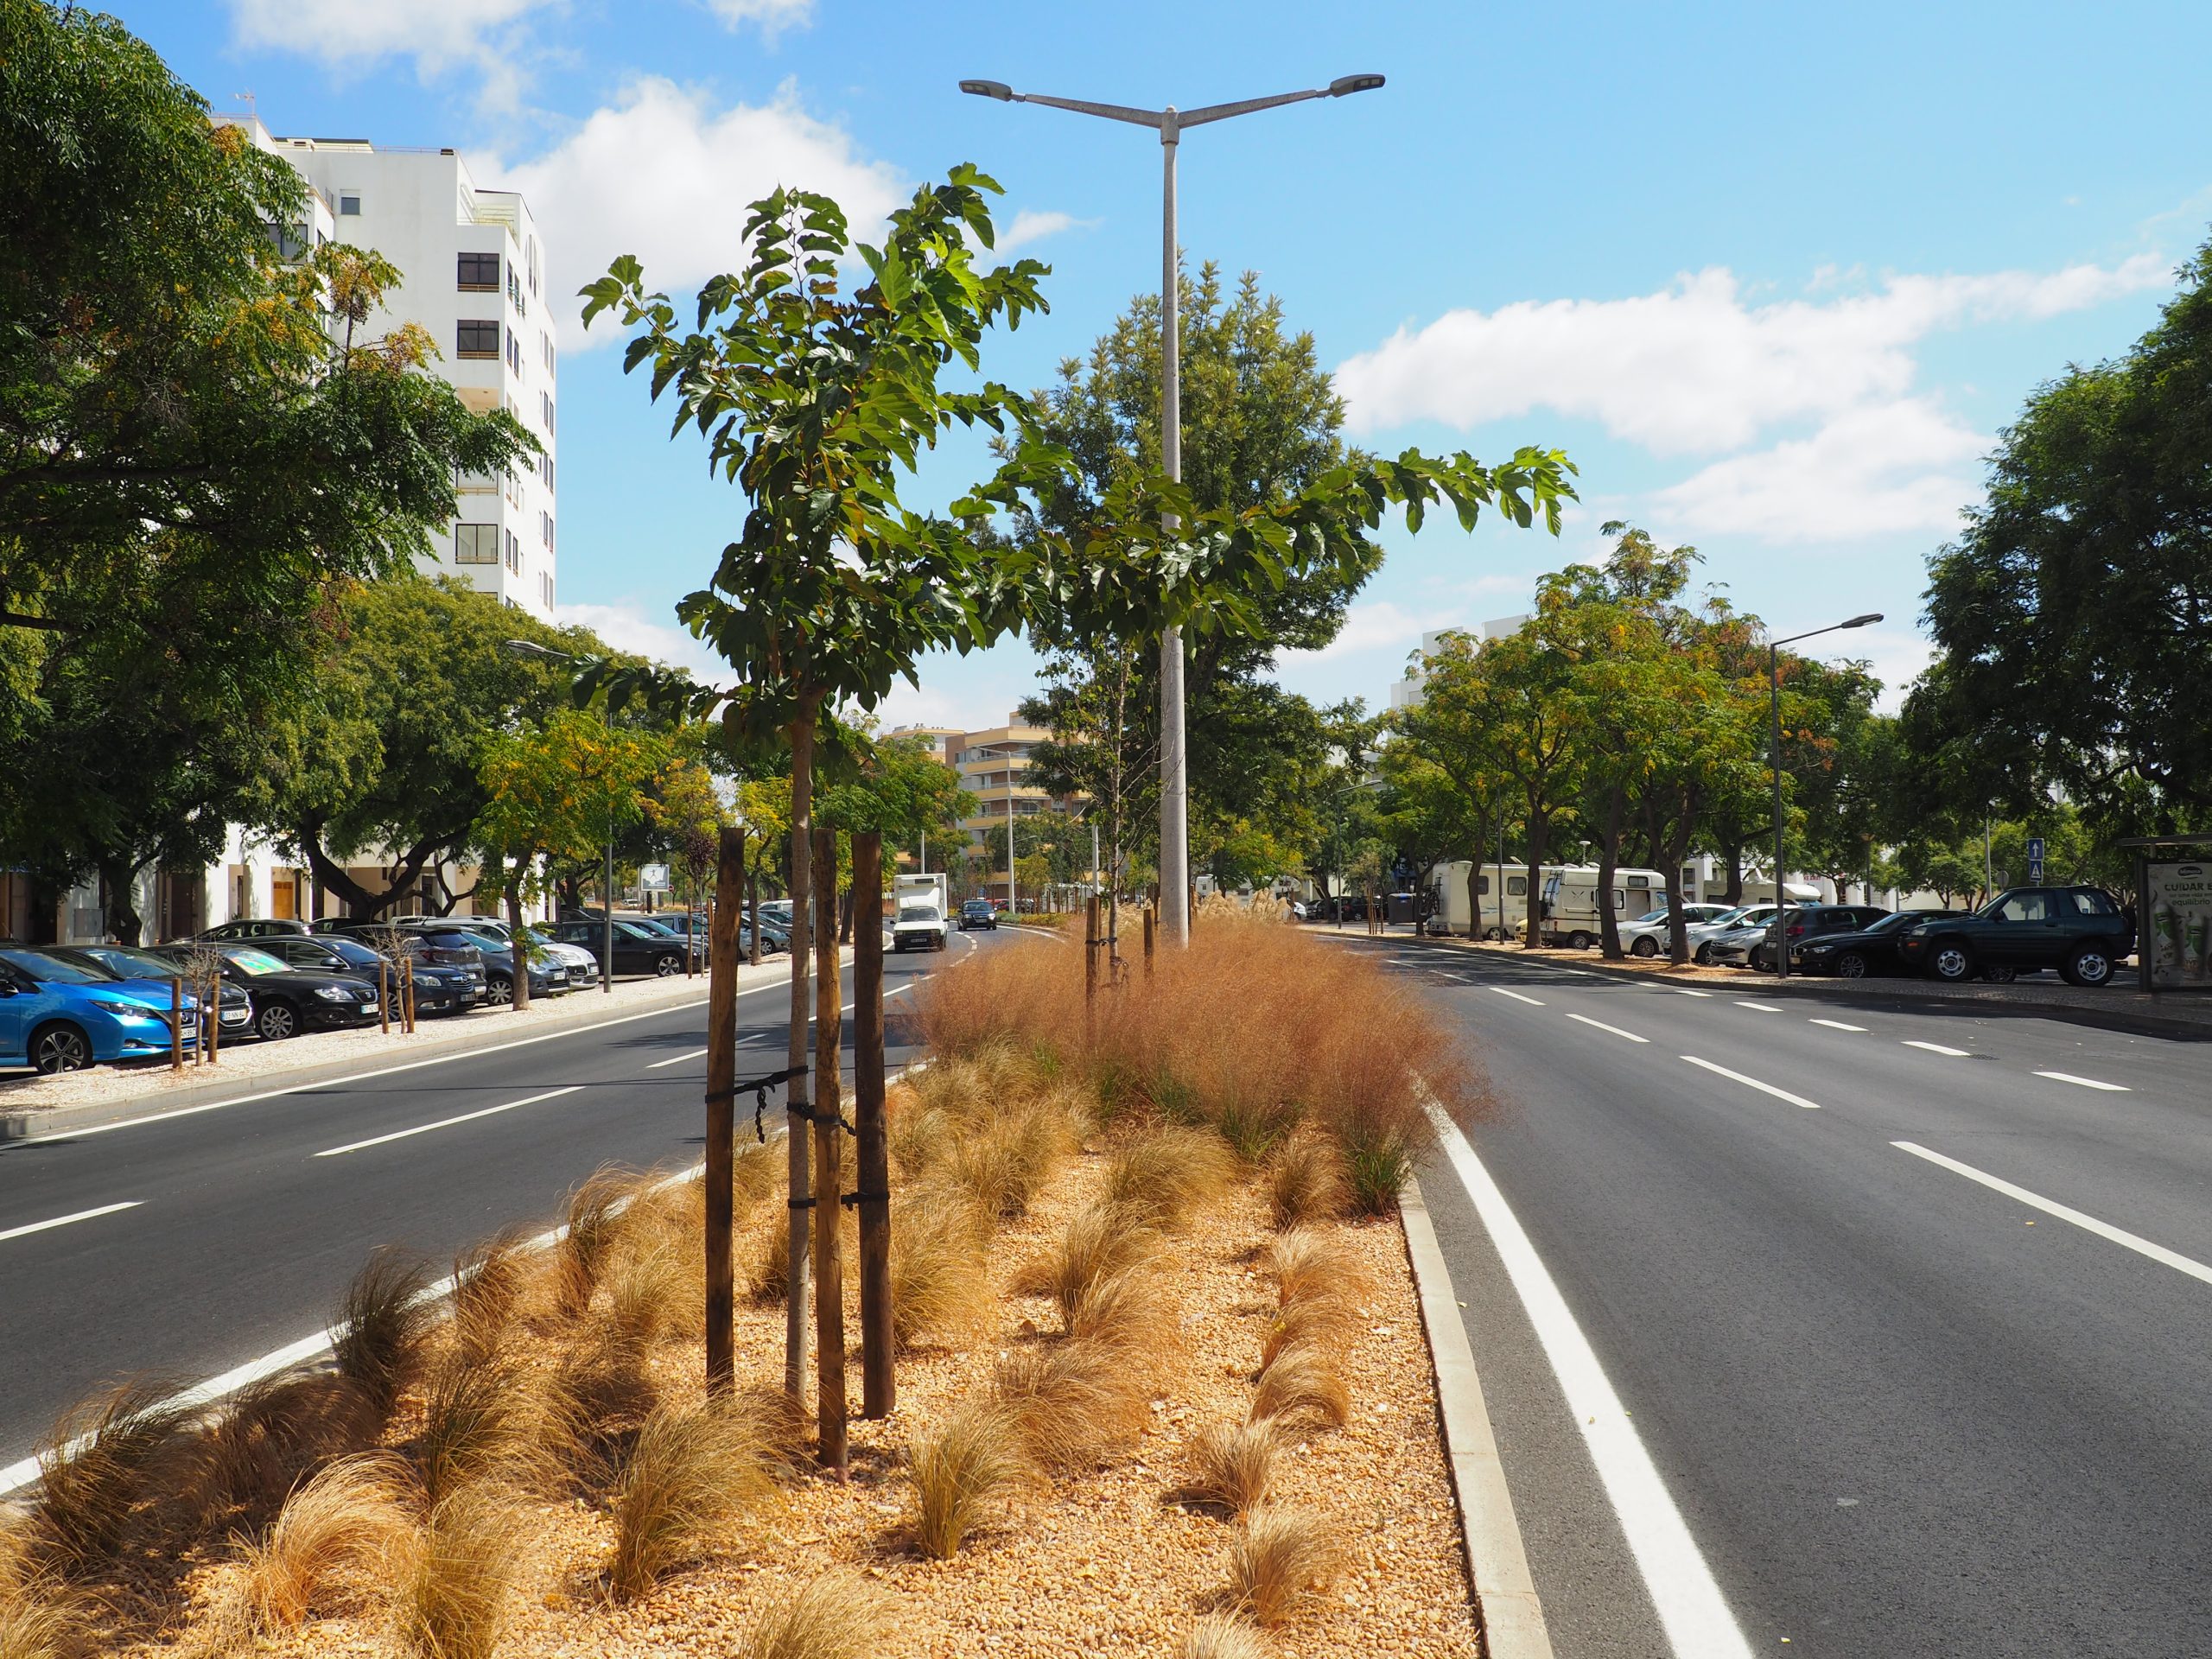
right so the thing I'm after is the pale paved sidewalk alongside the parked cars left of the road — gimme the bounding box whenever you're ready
[0,947,814,1141]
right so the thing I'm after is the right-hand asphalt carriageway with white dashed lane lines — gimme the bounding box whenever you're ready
[1351,940,2212,1659]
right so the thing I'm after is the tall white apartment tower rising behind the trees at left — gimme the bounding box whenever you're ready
[217,115,560,620]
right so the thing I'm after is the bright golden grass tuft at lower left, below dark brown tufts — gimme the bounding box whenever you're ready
[232,1453,414,1637]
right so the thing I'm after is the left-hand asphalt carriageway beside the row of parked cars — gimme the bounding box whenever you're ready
[0,933,1004,1466]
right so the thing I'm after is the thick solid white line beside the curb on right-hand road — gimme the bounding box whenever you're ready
[1427,1103,1752,1659]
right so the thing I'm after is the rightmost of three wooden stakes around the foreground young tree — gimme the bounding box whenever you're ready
[852,830,898,1418]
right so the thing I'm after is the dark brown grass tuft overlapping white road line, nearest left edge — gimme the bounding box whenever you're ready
[24,1382,190,1575]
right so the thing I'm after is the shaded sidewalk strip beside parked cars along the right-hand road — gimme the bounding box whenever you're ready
[1320,927,2212,1039]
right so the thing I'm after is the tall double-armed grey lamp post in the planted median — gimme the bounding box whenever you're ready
[960,75,1382,944]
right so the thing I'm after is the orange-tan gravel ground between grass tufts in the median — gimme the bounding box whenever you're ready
[111,1150,1480,1659]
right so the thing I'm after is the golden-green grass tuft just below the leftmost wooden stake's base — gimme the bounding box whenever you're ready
[606,1407,774,1601]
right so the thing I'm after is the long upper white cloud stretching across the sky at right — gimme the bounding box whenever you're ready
[1336,254,2170,454]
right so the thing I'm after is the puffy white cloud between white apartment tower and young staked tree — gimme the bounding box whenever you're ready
[499,75,907,349]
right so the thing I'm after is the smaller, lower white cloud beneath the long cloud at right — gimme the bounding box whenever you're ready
[1652,398,1993,542]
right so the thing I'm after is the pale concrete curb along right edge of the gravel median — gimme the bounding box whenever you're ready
[1398,1174,1551,1659]
